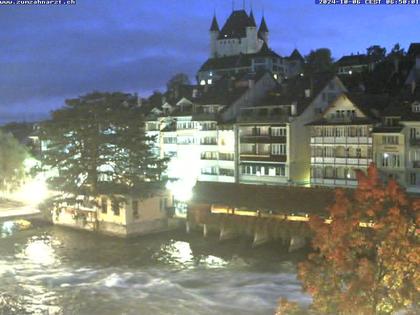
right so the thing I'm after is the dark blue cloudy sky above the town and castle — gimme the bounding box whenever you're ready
[0,0,420,122]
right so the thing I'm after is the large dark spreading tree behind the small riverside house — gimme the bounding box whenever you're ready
[41,93,166,205]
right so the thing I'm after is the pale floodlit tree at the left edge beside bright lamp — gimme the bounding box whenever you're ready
[0,131,27,191]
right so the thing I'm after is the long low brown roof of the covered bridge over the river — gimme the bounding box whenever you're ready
[190,182,335,214]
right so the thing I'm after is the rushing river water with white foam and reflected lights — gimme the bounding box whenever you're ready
[0,224,310,315]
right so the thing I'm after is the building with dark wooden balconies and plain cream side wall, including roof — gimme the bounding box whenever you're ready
[236,74,345,185]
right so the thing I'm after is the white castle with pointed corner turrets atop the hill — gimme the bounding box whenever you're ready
[197,10,304,85]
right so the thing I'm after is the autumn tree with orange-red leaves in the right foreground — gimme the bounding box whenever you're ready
[299,165,420,314]
